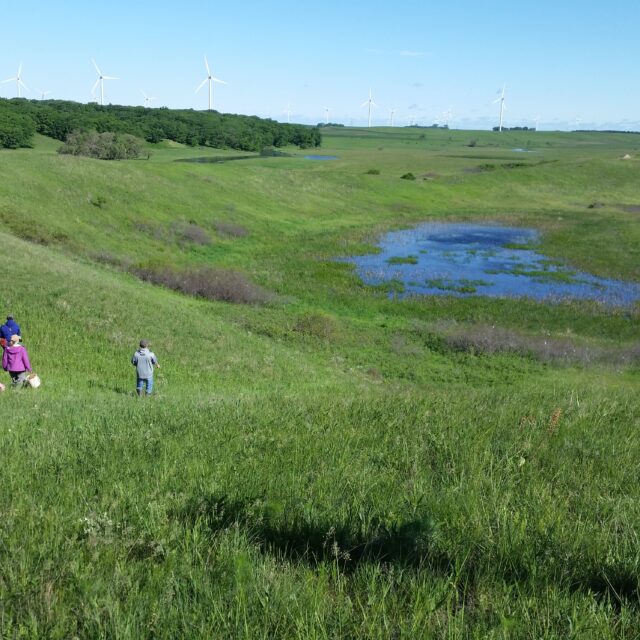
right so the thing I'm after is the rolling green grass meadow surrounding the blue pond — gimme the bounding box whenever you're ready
[0,128,640,639]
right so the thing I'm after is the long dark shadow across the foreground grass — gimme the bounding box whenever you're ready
[174,495,640,610]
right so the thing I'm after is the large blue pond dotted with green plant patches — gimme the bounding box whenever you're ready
[345,223,640,306]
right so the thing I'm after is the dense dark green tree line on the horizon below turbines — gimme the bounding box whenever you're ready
[0,98,322,151]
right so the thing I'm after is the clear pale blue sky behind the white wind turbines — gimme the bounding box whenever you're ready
[0,0,640,130]
